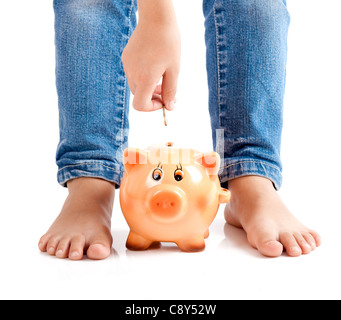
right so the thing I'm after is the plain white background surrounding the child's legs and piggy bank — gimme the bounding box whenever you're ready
[0,0,341,299]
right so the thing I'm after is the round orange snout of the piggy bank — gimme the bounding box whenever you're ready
[149,188,185,222]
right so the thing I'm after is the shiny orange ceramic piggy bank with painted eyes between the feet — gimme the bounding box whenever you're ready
[120,143,231,252]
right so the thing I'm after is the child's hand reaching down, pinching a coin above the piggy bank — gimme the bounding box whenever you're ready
[122,0,181,111]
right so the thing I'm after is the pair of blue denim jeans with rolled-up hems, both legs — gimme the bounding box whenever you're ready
[54,0,289,189]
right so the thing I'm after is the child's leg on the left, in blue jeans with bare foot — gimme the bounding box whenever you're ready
[39,0,136,259]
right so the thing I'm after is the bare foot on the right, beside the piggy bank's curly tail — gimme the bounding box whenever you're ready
[225,176,321,257]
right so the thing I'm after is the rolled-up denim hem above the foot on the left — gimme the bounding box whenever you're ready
[57,160,123,189]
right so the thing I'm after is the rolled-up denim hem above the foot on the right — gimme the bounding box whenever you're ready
[219,159,282,190]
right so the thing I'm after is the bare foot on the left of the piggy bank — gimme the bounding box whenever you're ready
[39,178,115,260]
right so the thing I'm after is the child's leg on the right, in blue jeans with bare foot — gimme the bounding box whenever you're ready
[204,0,320,256]
